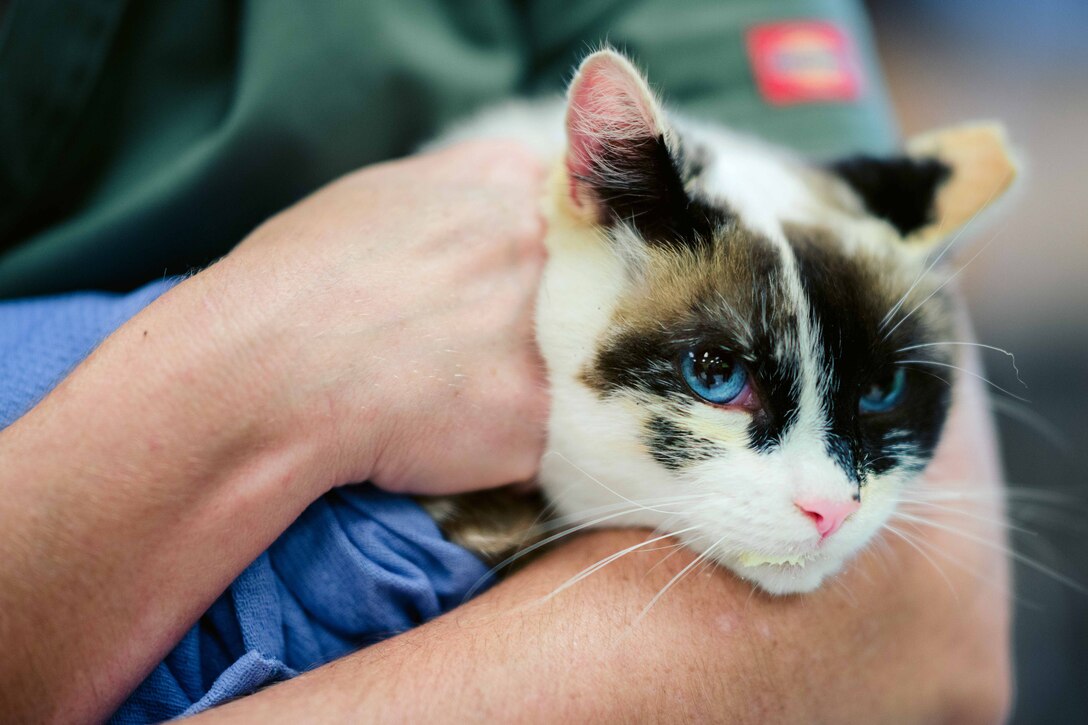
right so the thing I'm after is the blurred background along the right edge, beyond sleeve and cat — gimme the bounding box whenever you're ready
[868,0,1088,723]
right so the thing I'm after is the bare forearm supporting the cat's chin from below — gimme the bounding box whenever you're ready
[195,328,1012,723]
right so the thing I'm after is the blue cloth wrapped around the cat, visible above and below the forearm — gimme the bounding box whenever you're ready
[0,280,487,723]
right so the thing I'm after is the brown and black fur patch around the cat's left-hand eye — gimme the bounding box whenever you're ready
[583,224,802,469]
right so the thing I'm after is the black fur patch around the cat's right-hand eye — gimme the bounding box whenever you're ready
[786,219,950,483]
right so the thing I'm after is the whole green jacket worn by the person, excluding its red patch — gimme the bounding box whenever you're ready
[0,0,895,297]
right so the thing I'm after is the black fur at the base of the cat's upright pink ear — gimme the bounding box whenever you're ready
[579,136,729,247]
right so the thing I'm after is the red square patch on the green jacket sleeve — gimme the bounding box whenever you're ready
[745,21,862,106]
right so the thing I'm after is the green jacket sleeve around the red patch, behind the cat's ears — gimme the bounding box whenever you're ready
[527,0,898,156]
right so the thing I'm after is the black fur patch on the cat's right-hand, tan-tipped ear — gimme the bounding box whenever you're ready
[830,156,952,236]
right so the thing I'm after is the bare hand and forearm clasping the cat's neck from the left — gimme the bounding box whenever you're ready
[0,144,547,722]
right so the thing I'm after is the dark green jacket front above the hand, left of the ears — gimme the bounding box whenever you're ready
[0,0,527,297]
